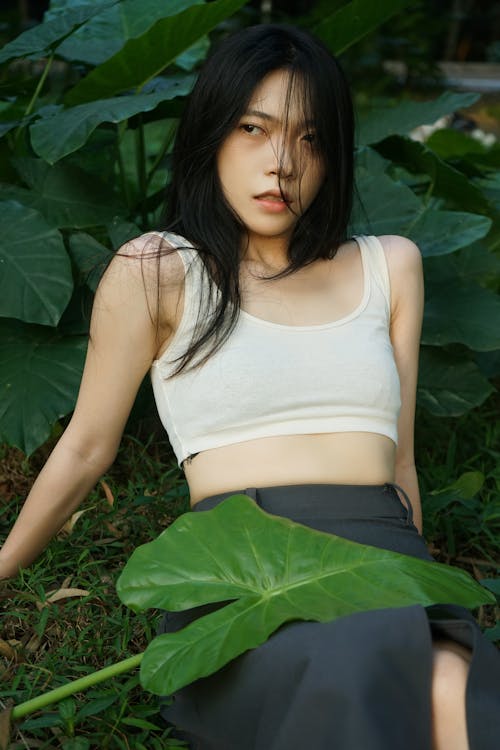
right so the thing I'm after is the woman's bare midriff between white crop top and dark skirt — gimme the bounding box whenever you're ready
[183,432,396,505]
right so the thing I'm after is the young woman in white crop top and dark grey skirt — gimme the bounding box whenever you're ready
[0,25,500,750]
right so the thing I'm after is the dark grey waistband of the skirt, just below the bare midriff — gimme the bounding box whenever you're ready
[193,482,413,526]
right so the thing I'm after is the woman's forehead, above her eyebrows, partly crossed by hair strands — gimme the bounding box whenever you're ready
[247,70,313,122]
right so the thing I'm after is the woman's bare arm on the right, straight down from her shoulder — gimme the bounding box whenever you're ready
[380,235,424,533]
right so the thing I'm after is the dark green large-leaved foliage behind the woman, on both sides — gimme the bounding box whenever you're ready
[0,0,500,453]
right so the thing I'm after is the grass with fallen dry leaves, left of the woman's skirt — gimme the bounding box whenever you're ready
[0,437,188,750]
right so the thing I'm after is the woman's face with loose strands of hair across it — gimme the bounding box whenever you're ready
[217,70,325,247]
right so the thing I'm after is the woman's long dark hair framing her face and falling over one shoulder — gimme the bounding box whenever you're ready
[164,24,354,373]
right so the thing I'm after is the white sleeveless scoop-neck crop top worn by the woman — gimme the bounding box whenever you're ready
[151,233,401,465]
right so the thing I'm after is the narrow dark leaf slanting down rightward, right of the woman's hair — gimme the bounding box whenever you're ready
[377,135,490,213]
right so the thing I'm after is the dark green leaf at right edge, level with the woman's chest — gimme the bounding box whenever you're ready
[422,274,500,352]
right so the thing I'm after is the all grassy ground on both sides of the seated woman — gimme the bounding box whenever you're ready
[0,396,500,750]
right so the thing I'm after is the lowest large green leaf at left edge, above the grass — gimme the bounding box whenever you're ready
[0,319,86,455]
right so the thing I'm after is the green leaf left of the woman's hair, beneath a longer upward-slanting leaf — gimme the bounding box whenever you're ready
[30,75,194,164]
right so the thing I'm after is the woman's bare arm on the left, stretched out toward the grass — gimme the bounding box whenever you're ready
[0,238,180,578]
